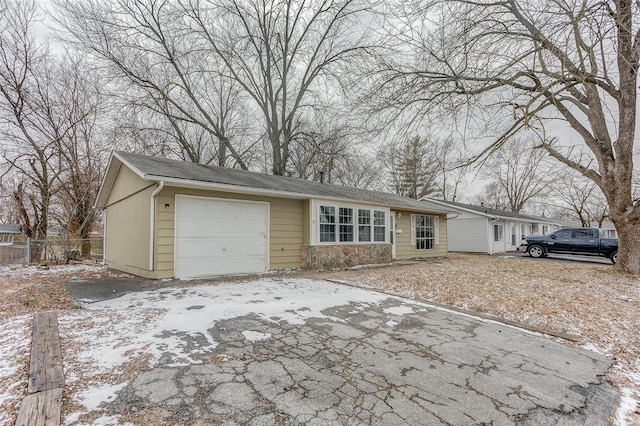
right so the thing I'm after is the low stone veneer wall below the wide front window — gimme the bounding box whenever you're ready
[302,244,392,269]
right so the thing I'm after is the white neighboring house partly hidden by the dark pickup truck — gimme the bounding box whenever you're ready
[425,198,563,254]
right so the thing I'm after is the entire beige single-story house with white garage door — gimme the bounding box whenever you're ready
[96,152,453,278]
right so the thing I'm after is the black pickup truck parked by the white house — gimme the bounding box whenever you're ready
[525,228,618,264]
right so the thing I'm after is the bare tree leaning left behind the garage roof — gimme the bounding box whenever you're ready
[56,0,252,169]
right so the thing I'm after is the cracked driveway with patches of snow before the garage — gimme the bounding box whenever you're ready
[61,278,617,425]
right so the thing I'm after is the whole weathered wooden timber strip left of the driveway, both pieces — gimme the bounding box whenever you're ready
[16,312,64,426]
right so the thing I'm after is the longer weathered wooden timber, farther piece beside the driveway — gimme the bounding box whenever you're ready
[27,312,64,393]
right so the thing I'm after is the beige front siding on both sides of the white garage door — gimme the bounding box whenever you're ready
[155,187,303,278]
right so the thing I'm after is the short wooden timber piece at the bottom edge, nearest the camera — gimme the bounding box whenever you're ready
[16,389,62,426]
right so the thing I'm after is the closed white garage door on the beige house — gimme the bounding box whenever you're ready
[174,196,269,278]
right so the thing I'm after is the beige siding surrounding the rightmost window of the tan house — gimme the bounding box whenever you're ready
[396,211,447,260]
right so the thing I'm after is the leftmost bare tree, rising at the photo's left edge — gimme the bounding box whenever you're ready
[0,0,59,260]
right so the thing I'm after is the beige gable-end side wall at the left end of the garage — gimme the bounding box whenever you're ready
[105,167,156,278]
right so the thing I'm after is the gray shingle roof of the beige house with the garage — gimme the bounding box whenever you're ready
[116,151,453,213]
